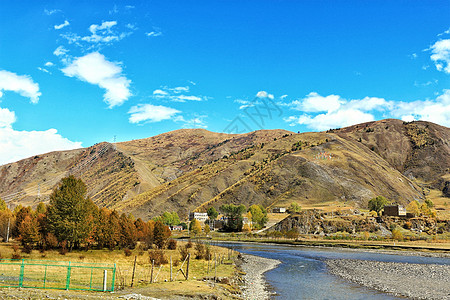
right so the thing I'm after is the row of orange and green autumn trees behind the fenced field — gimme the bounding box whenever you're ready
[0,176,173,251]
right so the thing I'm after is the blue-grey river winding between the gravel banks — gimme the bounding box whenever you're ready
[218,243,450,300]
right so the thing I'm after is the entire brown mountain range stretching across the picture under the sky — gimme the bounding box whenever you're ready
[0,120,450,219]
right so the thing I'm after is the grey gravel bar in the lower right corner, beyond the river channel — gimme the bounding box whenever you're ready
[326,259,450,299]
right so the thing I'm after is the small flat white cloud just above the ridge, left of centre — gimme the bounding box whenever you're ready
[128,104,180,123]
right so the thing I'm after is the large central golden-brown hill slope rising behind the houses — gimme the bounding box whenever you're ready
[110,133,422,218]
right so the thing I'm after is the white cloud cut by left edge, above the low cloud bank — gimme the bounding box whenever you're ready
[0,70,41,103]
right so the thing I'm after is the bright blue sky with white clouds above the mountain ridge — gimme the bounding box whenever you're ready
[0,0,450,164]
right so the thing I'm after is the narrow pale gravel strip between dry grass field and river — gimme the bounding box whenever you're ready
[241,254,281,299]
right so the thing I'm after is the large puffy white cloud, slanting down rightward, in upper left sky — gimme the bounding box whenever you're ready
[62,52,131,108]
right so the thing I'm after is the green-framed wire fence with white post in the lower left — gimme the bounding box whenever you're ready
[0,259,116,292]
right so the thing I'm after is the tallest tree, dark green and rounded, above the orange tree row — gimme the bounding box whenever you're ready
[47,175,95,250]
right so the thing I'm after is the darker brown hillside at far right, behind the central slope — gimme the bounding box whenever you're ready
[333,119,450,190]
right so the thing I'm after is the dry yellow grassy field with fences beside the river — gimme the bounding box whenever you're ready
[0,242,239,298]
